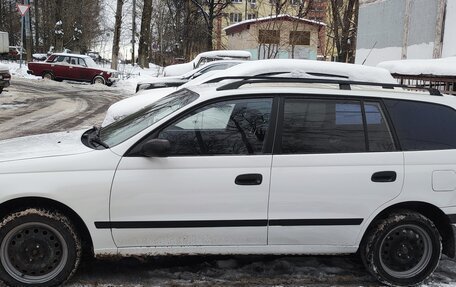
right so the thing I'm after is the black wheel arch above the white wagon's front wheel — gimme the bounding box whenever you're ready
[0,197,94,258]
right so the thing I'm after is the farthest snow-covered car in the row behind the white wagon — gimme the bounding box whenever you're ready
[163,50,252,77]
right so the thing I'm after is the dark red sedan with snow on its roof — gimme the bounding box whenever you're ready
[27,53,118,86]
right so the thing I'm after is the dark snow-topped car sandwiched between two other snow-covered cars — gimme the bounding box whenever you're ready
[136,60,245,92]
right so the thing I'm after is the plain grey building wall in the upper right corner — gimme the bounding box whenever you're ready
[356,0,456,65]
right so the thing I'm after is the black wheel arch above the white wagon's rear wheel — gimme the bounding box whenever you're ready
[360,201,456,258]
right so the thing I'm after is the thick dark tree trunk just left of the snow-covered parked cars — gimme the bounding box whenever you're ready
[138,0,152,68]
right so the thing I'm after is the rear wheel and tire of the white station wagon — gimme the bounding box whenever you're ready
[360,211,442,286]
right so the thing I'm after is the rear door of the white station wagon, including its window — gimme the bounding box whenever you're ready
[268,97,404,246]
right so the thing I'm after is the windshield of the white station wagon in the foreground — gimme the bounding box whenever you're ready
[100,89,198,147]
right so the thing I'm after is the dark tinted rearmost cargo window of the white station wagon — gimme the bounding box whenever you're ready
[384,100,456,151]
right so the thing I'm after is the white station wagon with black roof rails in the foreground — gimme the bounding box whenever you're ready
[0,72,456,286]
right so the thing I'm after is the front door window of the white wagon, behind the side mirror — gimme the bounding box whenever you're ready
[158,98,272,156]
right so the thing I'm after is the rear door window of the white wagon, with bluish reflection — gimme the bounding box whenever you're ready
[281,98,396,154]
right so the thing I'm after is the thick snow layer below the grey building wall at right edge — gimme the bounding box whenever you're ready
[377,57,456,76]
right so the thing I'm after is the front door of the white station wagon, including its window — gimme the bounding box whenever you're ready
[111,98,273,247]
